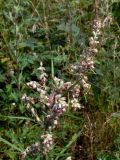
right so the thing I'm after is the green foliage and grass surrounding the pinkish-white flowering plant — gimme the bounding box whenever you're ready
[0,0,120,160]
